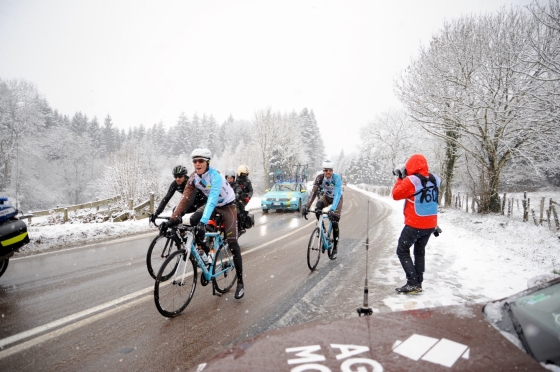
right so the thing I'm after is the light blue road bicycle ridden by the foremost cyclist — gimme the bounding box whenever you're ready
[154,219,237,318]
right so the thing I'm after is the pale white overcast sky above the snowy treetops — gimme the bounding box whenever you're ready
[0,0,531,155]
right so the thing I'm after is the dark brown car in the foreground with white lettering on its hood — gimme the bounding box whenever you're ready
[197,277,560,372]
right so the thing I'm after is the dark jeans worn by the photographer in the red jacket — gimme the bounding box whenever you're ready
[397,225,435,286]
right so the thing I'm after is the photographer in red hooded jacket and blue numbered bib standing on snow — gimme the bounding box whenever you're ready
[392,154,441,294]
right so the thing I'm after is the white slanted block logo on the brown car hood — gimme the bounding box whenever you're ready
[393,334,470,368]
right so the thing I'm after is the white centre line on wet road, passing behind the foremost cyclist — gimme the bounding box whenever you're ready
[0,221,316,359]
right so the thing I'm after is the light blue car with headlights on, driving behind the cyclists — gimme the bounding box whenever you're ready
[261,181,309,213]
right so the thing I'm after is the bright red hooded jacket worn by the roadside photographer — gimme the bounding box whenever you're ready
[392,154,437,229]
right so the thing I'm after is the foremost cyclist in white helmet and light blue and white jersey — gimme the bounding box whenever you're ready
[169,148,245,299]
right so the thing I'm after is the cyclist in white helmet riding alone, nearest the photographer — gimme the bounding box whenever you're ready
[302,160,343,260]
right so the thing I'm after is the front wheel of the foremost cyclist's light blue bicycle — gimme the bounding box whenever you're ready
[154,249,197,318]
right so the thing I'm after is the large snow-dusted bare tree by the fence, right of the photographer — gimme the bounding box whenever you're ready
[397,8,556,212]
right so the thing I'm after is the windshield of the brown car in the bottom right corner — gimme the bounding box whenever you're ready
[509,283,560,365]
